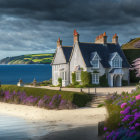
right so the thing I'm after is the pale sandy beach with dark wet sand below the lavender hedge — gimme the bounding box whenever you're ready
[0,103,107,140]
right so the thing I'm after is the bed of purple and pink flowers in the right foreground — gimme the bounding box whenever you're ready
[104,89,140,140]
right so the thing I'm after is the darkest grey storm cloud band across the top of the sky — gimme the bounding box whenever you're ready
[0,0,140,26]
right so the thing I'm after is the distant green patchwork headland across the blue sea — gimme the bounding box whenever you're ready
[0,53,54,64]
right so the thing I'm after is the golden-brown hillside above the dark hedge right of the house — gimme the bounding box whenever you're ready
[122,38,140,49]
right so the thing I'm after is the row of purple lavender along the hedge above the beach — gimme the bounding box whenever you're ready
[0,91,75,109]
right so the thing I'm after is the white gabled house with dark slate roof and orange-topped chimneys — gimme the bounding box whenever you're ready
[52,30,129,87]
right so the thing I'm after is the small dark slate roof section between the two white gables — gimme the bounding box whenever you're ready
[62,46,73,62]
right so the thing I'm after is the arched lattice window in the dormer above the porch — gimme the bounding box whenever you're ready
[112,55,122,68]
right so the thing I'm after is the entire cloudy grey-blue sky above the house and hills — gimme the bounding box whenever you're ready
[0,0,140,58]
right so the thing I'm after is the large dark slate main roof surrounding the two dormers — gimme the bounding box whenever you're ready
[79,42,129,68]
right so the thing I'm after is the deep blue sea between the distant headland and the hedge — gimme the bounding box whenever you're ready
[0,64,52,85]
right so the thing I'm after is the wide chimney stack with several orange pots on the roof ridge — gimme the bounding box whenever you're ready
[95,32,107,44]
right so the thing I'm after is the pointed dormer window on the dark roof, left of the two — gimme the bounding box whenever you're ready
[90,53,100,69]
